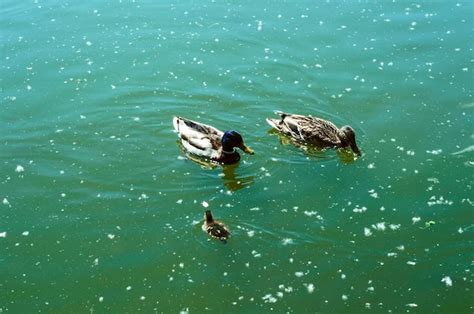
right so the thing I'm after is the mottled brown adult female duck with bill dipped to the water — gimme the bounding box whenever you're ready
[267,111,361,156]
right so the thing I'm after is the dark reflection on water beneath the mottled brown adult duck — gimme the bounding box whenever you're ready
[267,129,358,164]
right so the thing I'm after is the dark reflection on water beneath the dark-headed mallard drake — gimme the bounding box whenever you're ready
[177,140,255,192]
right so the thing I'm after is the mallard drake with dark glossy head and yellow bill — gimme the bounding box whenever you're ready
[173,117,254,164]
